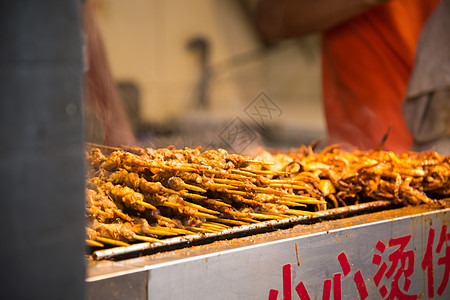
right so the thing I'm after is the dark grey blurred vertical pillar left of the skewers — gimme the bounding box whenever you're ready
[0,0,85,299]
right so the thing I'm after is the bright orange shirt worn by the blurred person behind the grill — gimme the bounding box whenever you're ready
[322,0,440,152]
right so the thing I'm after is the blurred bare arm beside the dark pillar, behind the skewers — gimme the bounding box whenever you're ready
[82,0,137,146]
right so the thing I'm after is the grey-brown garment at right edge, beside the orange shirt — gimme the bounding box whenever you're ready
[403,0,450,155]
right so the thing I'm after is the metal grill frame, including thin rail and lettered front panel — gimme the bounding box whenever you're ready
[86,201,450,299]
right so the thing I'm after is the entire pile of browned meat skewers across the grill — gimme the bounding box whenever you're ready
[86,146,450,247]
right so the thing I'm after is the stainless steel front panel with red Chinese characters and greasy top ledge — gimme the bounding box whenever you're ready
[86,206,450,299]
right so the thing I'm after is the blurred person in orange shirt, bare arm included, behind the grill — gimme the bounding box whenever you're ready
[256,0,450,152]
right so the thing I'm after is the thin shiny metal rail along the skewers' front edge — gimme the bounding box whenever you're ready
[92,201,392,260]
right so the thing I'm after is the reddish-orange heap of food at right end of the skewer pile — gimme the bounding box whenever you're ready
[259,145,450,208]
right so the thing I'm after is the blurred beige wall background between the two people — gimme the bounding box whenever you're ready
[87,0,326,153]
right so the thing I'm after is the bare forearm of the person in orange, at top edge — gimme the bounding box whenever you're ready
[256,0,389,41]
